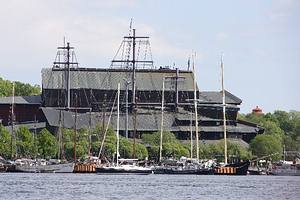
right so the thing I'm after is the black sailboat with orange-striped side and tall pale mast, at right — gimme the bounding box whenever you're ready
[214,56,250,175]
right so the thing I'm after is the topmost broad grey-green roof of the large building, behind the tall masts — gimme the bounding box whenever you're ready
[42,68,194,91]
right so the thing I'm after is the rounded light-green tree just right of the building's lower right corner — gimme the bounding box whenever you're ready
[250,134,282,160]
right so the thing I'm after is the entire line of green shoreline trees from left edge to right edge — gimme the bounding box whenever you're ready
[0,111,300,161]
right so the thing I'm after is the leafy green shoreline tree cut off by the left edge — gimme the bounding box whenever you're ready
[0,125,11,159]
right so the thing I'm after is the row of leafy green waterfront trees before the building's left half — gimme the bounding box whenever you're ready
[0,126,148,160]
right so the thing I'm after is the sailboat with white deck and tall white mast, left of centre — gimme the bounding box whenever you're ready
[96,83,153,174]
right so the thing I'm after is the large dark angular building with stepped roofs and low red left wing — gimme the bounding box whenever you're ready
[0,37,264,143]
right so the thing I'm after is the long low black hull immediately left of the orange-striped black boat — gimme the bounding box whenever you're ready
[154,168,214,175]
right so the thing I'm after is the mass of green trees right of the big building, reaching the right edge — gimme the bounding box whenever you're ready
[239,110,300,160]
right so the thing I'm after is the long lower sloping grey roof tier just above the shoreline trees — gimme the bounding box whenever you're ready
[42,108,260,133]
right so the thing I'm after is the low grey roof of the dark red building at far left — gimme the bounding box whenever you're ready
[0,95,41,104]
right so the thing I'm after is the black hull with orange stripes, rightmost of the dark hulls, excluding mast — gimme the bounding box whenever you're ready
[214,161,250,175]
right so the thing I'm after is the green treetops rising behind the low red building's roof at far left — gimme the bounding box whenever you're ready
[0,77,41,97]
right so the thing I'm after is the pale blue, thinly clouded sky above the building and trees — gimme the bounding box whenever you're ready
[0,0,300,113]
